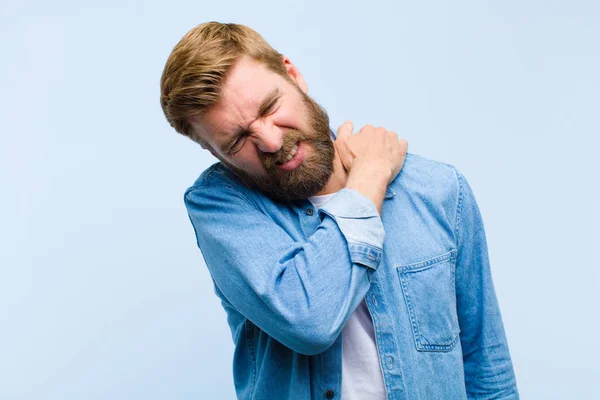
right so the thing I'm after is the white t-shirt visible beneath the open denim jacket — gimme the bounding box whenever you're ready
[308,193,386,400]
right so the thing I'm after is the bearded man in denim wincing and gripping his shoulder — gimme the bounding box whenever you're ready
[161,22,518,400]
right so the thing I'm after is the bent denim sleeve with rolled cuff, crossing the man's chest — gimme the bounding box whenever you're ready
[185,185,384,355]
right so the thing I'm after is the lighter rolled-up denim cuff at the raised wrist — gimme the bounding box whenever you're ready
[319,188,385,269]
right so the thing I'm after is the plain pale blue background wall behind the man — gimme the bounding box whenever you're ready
[0,0,600,400]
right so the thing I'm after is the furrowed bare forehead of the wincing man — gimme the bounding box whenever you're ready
[191,57,285,142]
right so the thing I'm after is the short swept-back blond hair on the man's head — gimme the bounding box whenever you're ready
[160,22,289,145]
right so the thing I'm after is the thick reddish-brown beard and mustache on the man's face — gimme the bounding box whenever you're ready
[221,89,335,203]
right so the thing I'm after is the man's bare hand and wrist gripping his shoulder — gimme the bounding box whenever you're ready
[334,121,408,214]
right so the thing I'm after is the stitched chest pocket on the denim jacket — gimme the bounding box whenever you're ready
[397,250,460,352]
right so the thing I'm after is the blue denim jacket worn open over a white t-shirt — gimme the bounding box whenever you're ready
[185,154,519,400]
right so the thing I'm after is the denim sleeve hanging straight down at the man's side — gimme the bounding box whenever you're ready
[455,172,519,399]
